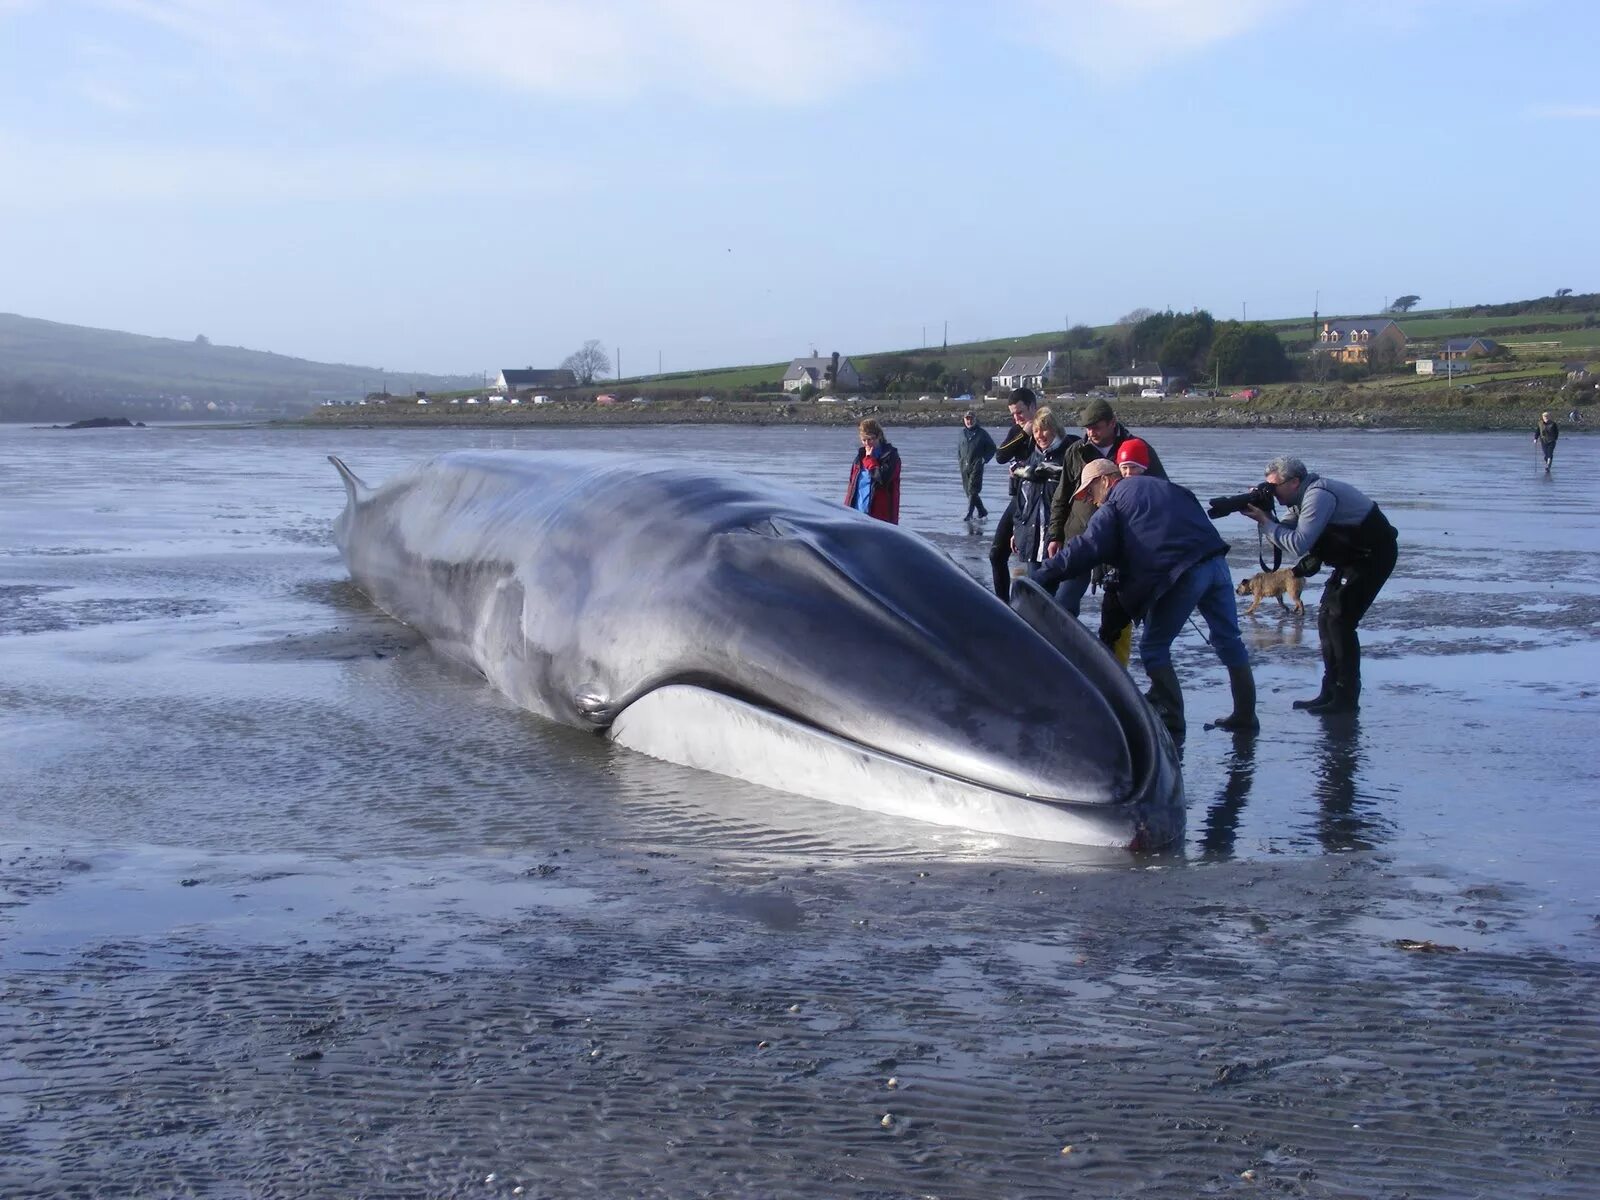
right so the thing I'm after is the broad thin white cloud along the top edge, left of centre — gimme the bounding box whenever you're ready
[93,0,907,106]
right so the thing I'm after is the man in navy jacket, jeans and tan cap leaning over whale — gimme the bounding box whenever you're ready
[1034,459,1261,738]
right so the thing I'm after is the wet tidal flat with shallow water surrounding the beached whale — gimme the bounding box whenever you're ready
[0,427,1600,1195]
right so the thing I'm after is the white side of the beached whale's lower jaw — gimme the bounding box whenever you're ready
[610,683,1168,850]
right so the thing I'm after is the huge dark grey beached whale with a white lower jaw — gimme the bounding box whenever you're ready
[331,451,1182,848]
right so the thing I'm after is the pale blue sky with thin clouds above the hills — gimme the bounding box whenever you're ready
[0,0,1600,374]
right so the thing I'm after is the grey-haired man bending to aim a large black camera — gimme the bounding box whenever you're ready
[1211,458,1400,715]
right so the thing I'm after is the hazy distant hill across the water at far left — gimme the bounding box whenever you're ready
[0,314,478,421]
